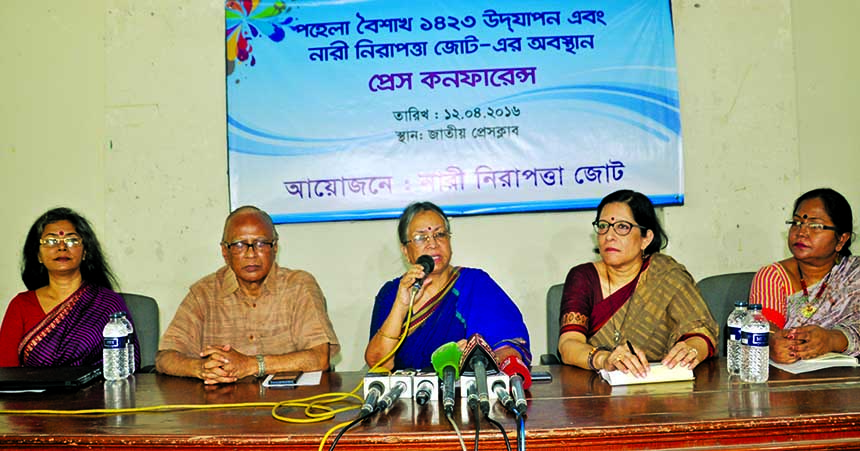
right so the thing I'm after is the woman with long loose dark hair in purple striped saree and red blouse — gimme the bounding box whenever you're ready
[0,208,140,366]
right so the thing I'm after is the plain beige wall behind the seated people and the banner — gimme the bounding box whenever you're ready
[0,0,860,370]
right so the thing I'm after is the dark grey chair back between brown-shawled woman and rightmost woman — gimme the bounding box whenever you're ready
[696,272,755,356]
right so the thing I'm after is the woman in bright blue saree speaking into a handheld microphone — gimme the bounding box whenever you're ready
[364,202,531,370]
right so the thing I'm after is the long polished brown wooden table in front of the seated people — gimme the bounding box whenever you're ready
[0,359,860,450]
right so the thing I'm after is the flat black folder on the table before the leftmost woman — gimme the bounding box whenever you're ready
[0,366,102,391]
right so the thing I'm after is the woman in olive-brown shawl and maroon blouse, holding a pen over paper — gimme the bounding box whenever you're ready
[558,190,717,377]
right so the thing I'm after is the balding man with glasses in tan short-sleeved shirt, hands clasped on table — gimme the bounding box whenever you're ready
[155,206,340,384]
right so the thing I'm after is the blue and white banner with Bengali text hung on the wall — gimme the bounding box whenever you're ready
[226,0,683,223]
